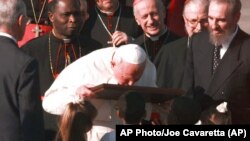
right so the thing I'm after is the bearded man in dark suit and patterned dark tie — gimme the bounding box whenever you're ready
[184,0,250,124]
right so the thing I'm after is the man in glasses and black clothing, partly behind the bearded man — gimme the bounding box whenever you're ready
[154,0,209,88]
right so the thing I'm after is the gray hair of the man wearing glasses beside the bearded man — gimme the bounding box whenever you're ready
[183,0,209,15]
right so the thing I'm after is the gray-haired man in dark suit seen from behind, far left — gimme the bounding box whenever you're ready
[0,0,44,141]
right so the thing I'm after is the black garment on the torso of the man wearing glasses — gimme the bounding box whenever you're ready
[154,37,188,88]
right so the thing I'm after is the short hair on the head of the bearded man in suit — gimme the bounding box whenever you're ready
[209,0,241,17]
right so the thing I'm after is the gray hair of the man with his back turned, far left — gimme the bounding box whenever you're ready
[0,0,27,27]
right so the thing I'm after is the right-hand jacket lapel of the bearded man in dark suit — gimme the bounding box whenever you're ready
[208,31,242,96]
